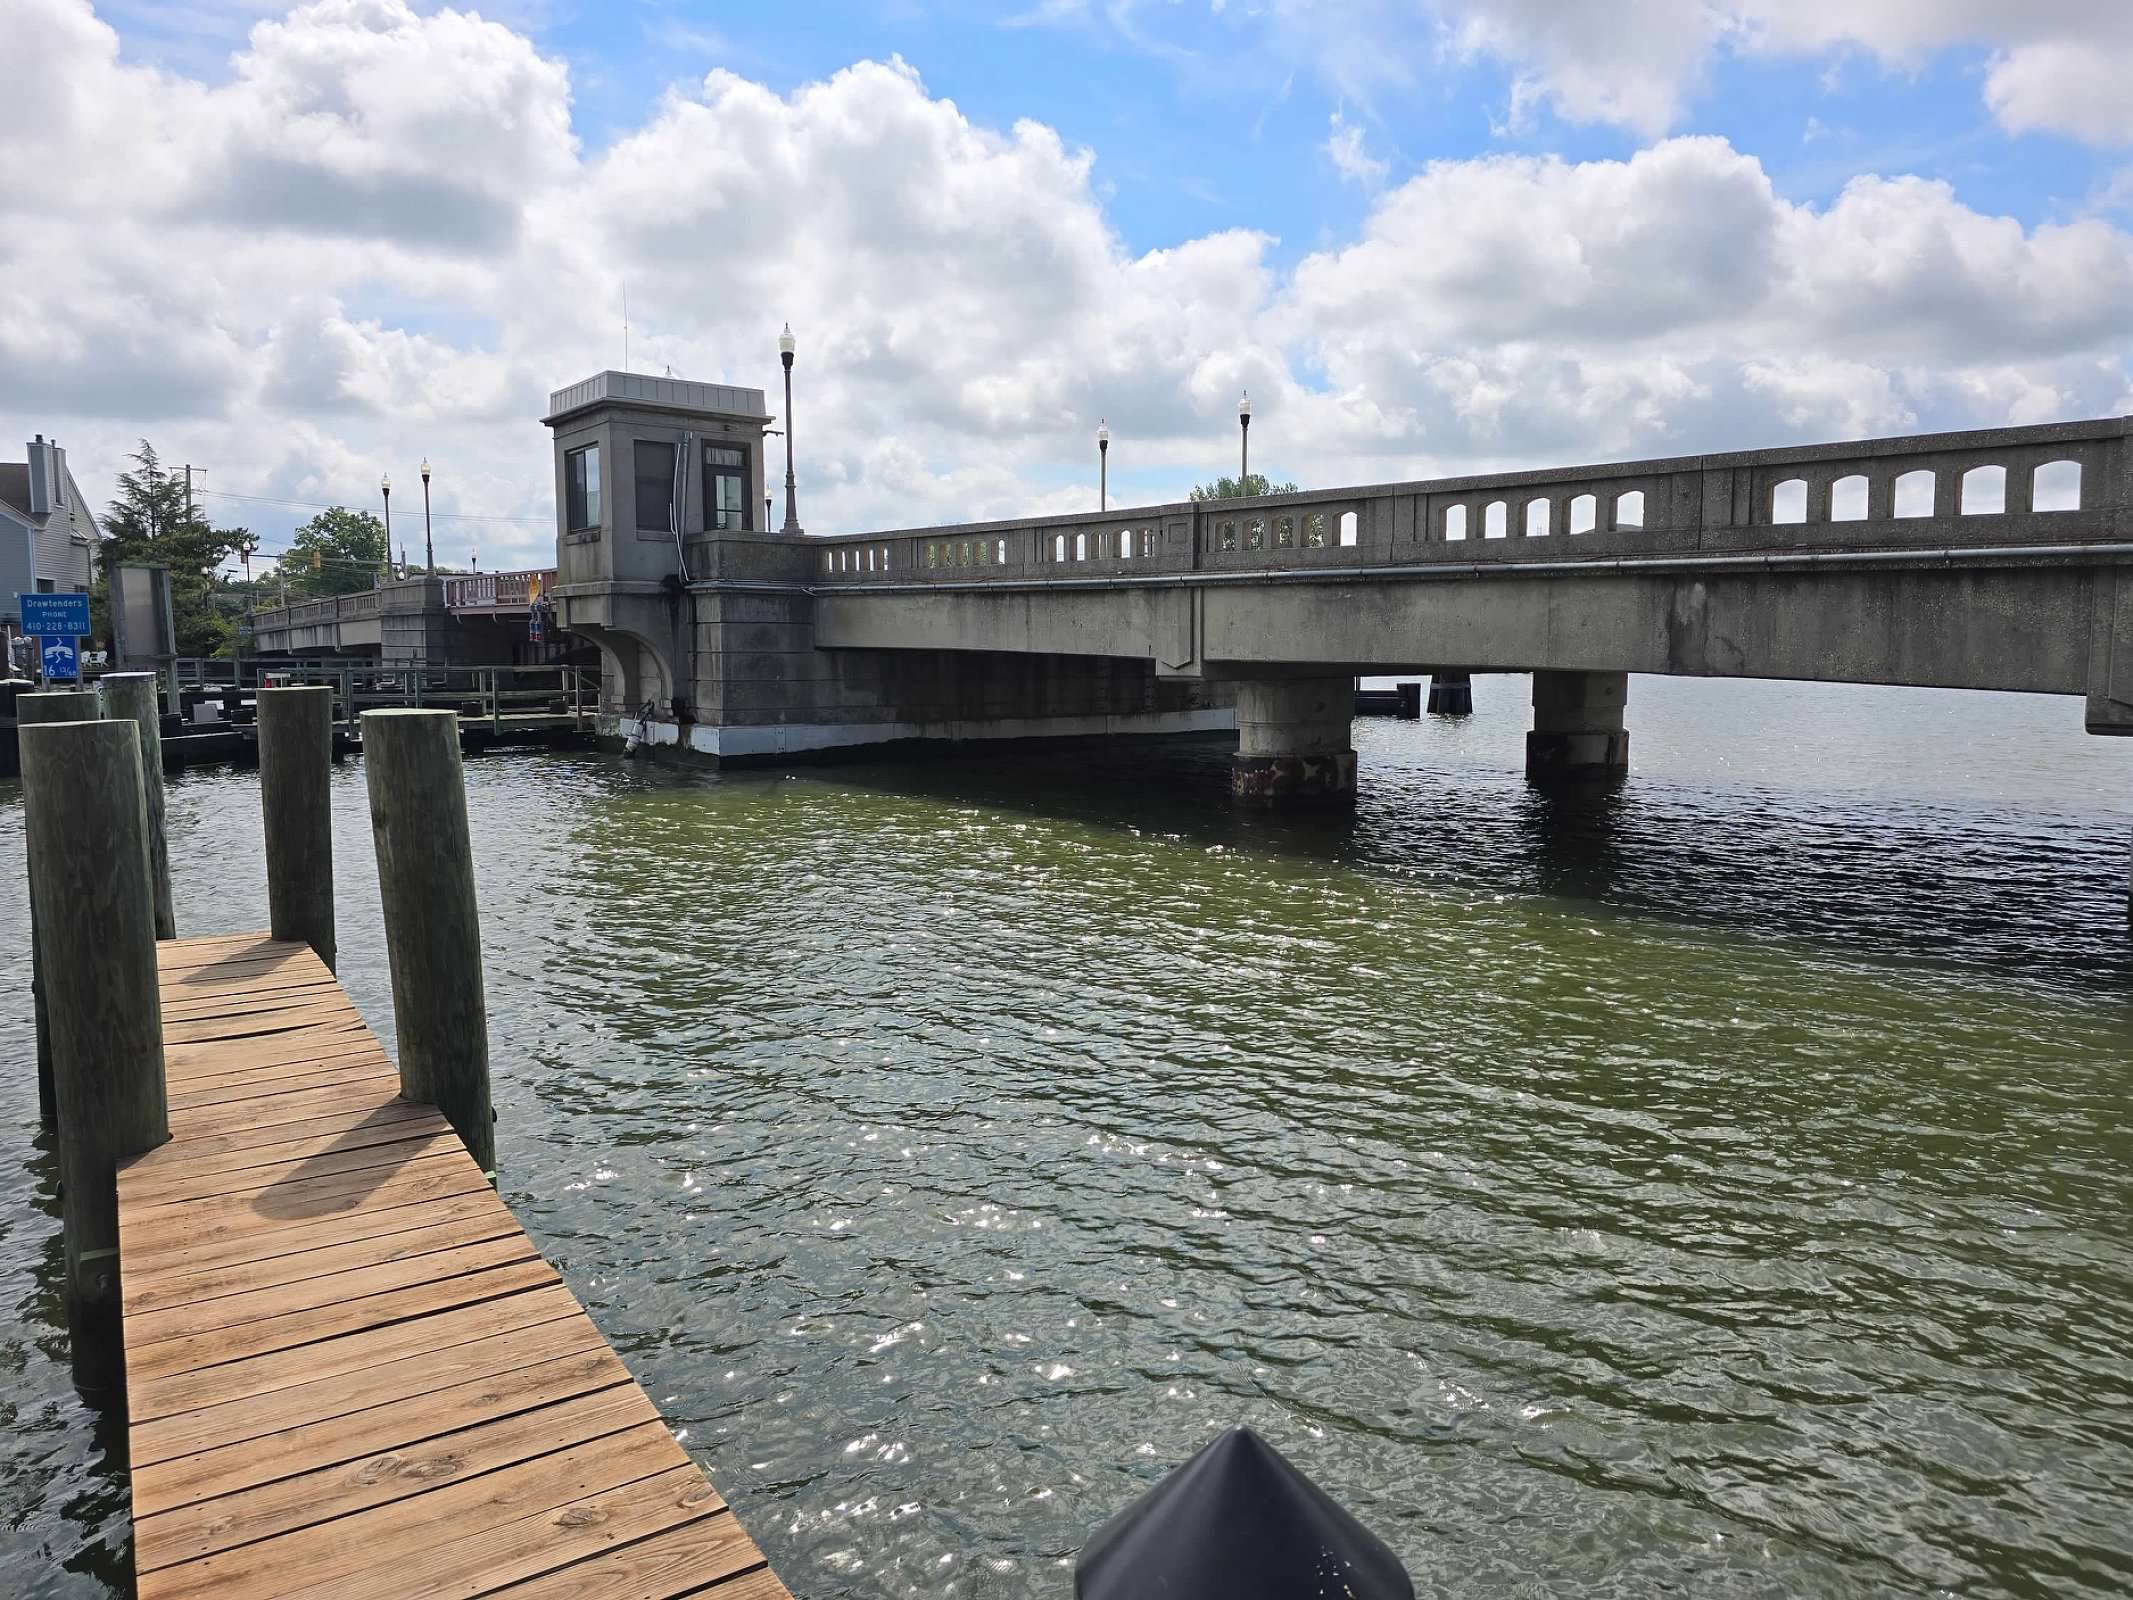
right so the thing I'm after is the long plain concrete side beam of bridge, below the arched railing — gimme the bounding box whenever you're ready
[815,563,2133,721]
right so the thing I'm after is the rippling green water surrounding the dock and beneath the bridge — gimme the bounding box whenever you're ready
[0,681,2133,1596]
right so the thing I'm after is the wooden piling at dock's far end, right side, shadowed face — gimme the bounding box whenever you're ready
[258,685,335,973]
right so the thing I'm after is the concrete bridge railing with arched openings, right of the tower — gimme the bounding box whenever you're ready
[817,418,2133,587]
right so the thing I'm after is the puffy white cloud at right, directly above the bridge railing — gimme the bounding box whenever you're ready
[1282,139,2133,465]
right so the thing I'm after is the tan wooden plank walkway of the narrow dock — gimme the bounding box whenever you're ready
[119,934,789,1600]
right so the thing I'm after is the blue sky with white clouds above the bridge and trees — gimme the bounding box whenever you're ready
[0,0,2133,567]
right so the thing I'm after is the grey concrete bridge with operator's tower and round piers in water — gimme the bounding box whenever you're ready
[546,373,2133,798]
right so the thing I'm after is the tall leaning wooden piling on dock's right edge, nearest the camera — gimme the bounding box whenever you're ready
[363,708,497,1173]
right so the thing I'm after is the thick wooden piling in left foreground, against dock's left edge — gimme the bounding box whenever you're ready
[21,719,171,1395]
